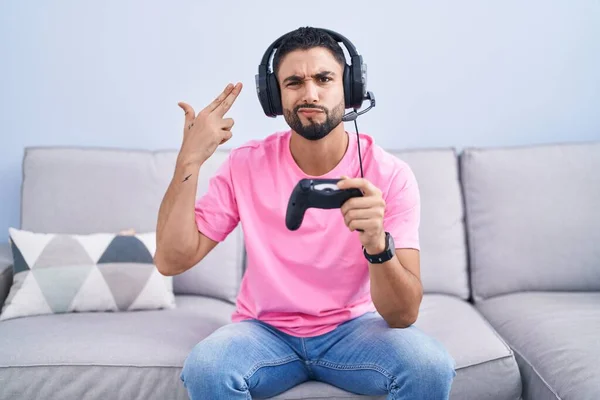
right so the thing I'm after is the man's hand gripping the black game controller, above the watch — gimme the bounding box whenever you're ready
[338,176,385,254]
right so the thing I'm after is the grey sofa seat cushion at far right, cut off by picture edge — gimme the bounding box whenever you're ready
[478,292,600,400]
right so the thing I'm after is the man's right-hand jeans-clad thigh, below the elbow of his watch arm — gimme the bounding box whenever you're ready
[307,313,455,399]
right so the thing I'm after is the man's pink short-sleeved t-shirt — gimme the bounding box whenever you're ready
[196,131,420,337]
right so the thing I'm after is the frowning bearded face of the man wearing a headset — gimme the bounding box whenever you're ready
[278,47,345,140]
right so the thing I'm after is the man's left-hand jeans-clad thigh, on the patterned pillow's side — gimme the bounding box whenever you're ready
[181,321,308,399]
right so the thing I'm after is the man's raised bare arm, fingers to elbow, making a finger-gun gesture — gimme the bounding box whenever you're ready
[154,83,242,275]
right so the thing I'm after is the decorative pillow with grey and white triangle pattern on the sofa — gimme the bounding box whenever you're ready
[0,228,175,320]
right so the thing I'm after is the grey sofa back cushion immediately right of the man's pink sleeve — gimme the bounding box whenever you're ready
[391,149,470,299]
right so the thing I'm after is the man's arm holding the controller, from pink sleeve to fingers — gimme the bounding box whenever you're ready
[338,168,423,328]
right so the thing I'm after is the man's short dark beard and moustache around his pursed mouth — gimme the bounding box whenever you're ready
[283,101,344,140]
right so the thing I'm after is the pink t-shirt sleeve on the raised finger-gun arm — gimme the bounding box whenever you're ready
[195,153,239,242]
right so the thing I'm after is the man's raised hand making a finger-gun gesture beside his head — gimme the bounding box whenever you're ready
[178,82,242,166]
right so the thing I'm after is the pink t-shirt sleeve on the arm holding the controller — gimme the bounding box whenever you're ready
[383,164,421,250]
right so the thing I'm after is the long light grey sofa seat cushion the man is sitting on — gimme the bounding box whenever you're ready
[0,295,520,400]
